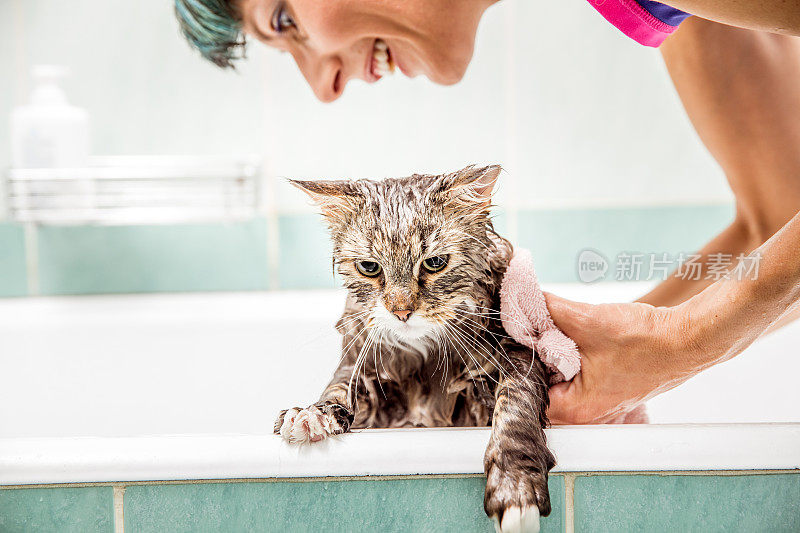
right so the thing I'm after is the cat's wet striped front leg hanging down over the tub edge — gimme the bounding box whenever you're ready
[483,350,555,532]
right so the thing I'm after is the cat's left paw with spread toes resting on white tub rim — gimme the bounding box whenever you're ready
[274,403,353,444]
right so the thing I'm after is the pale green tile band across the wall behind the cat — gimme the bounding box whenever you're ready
[0,206,733,296]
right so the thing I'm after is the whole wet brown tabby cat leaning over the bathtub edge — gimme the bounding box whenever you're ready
[275,166,555,531]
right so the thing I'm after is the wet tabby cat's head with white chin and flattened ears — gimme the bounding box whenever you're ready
[292,165,500,342]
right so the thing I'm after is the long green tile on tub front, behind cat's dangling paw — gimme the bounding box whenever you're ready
[125,476,564,533]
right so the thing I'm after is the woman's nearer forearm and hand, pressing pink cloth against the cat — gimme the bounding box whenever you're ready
[547,209,800,424]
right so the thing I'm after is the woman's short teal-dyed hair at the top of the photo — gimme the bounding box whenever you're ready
[175,0,245,68]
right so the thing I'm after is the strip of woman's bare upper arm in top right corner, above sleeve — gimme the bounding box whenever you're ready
[659,0,800,35]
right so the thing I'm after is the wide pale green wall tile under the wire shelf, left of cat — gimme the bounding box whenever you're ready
[39,219,268,295]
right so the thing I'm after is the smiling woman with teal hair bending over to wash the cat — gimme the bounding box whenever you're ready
[176,0,800,423]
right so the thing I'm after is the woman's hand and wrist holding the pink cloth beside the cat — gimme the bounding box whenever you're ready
[546,294,706,424]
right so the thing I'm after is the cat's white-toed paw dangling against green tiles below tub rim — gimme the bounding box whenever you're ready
[483,463,550,533]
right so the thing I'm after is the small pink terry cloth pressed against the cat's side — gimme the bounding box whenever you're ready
[500,249,581,383]
